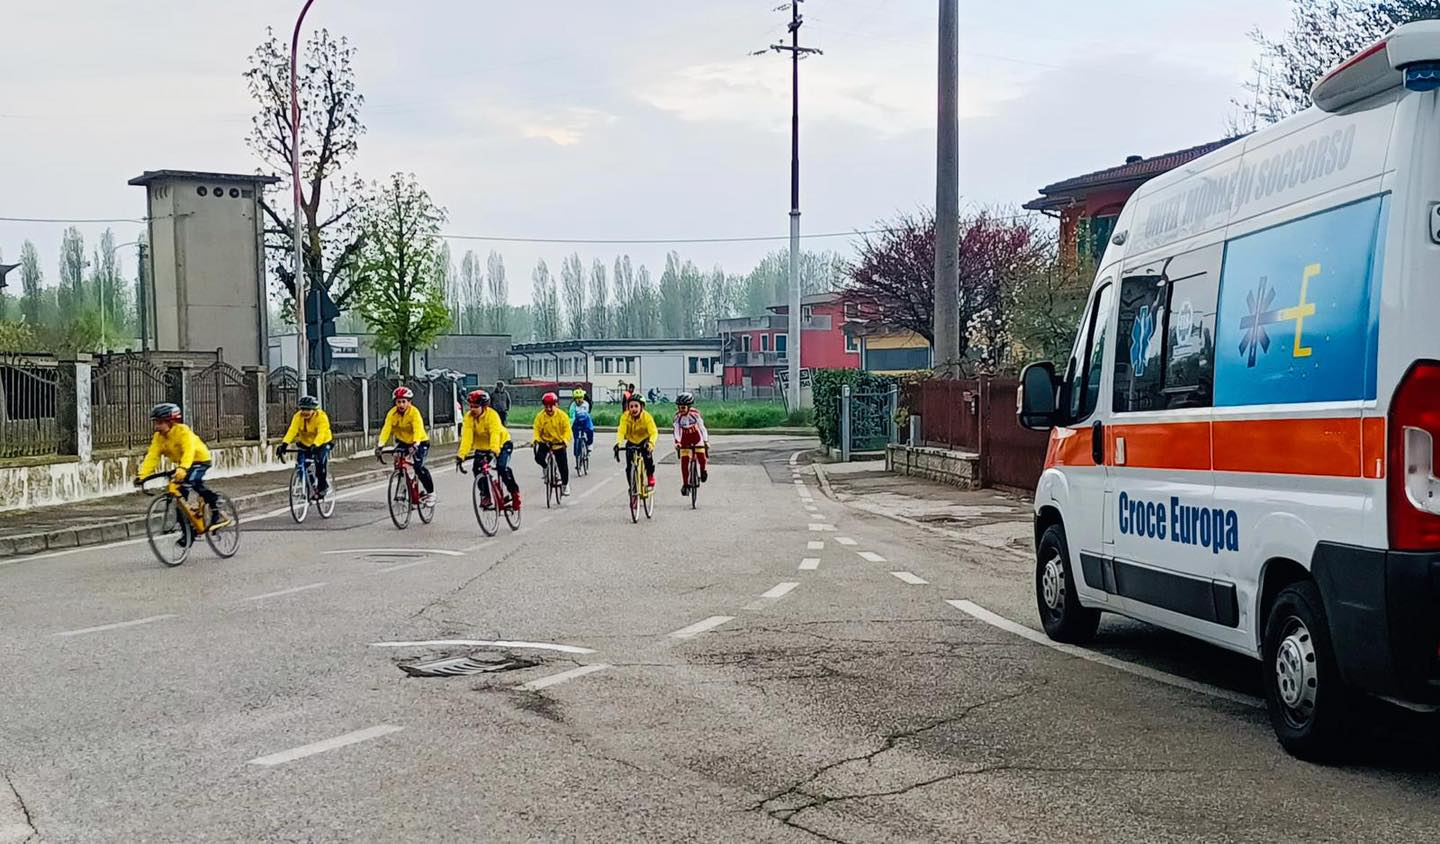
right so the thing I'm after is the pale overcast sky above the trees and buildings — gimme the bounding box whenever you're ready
[0,0,1287,302]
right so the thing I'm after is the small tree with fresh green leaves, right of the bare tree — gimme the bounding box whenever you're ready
[359,173,451,376]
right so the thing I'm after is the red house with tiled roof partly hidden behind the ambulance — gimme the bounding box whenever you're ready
[1025,137,1240,262]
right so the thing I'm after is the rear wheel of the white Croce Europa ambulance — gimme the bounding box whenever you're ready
[1263,580,1358,762]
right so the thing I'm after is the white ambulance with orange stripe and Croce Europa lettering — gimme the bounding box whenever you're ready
[1020,22,1440,759]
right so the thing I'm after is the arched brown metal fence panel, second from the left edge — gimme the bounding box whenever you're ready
[91,354,180,448]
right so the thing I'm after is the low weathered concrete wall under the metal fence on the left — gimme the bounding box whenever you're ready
[0,425,455,511]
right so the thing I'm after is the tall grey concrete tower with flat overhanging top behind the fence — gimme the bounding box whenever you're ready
[130,170,278,366]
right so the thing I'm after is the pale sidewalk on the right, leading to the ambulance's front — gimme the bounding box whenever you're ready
[815,462,1035,560]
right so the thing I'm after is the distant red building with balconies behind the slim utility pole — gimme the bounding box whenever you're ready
[719,292,860,387]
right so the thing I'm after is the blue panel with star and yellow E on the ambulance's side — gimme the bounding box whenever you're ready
[1215,194,1390,406]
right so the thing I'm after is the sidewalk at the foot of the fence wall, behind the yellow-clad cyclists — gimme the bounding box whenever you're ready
[0,455,390,559]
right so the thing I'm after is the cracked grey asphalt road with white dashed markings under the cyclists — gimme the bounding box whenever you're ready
[0,438,1440,844]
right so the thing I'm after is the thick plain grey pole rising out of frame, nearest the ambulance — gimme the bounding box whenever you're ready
[933,0,960,377]
